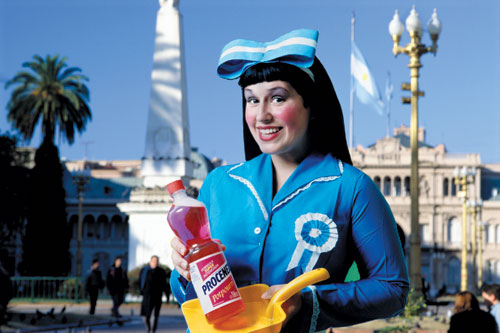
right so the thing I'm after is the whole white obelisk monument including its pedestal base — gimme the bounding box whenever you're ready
[118,0,193,270]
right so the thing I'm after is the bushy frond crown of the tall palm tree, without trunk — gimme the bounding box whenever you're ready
[5,55,92,144]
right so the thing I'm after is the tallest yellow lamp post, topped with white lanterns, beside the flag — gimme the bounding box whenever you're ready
[389,6,441,295]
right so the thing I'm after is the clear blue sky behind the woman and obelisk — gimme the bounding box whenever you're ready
[0,0,500,163]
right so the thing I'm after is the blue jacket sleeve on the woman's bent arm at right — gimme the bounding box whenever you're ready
[287,174,409,332]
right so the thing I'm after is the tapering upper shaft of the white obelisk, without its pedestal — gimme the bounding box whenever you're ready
[141,0,193,187]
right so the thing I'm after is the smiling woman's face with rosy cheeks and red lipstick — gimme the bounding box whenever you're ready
[243,81,309,161]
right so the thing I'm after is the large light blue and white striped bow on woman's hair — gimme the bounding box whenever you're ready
[217,29,318,79]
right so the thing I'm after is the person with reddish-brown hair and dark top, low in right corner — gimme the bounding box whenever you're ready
[448,291,498,333]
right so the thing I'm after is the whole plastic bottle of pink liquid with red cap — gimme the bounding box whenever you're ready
[167,180,245,323]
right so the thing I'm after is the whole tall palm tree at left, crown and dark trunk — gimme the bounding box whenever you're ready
[6,55,91,276]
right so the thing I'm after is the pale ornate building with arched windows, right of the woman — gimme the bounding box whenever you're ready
[351,126,500,294]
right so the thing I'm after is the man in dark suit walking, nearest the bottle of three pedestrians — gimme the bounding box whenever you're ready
[139,255,170,333]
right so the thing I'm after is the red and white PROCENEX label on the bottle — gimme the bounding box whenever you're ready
[189,252,241,314]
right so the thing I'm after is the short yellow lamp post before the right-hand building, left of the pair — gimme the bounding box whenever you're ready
[454,167,476,291]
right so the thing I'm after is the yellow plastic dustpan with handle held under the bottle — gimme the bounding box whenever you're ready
[182,268,330,333]
